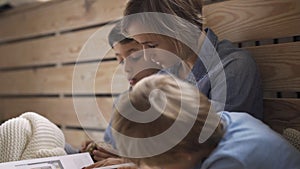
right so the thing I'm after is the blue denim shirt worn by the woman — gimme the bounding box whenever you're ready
[161,29,263,120]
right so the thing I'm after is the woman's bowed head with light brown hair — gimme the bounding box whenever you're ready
[122,0,202,67]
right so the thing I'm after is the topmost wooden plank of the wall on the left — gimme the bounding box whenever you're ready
[0,0,126,41]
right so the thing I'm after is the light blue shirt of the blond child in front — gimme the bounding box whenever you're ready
[194,112,300,169]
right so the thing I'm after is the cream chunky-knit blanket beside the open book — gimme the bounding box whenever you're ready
[0,112,66,163]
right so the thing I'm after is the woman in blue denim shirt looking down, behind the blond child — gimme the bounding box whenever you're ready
[122,0,263,119]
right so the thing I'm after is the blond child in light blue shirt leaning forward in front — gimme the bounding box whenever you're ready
[112,75,300,169]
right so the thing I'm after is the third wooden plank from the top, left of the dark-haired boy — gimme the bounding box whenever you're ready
[0,61,129,95]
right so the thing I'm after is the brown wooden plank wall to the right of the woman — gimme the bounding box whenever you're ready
[203,0,300,133]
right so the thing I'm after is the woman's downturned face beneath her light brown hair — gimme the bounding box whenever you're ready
[128,23,181,68]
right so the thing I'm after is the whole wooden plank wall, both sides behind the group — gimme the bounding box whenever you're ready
[0,0,300,147]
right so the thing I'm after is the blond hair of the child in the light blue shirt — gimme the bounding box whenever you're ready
[112,75,224,166]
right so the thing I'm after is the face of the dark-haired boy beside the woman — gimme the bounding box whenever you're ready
[114,41,161,86]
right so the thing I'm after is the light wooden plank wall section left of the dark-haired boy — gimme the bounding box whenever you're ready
[0,0,125,147]
